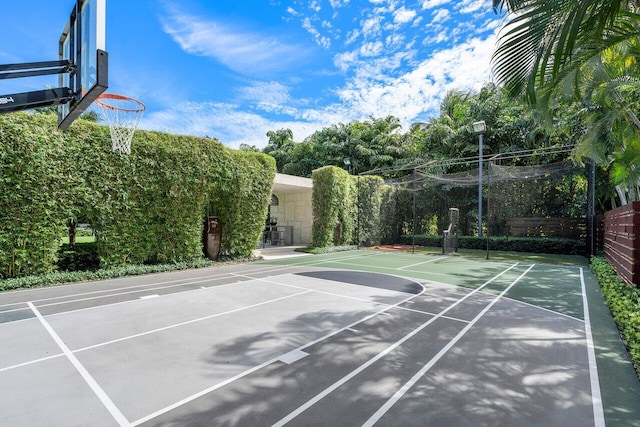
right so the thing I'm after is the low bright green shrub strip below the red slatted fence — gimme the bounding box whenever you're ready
[591,257,640,378]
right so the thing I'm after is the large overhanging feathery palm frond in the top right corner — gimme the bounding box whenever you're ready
[493,0,640,101]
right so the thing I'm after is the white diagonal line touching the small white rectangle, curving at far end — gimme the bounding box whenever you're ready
[131,281,425,426]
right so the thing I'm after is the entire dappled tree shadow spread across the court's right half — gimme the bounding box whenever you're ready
[141,269,640,426]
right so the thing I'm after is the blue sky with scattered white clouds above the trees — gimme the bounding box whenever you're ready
[0,0,504,148]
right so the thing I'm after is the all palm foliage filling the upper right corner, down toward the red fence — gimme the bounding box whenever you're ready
[493,0,640,202]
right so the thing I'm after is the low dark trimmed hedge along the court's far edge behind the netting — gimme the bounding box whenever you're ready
[400,235,587,255]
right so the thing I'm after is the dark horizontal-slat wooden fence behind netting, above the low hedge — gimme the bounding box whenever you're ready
[509,217,587,239]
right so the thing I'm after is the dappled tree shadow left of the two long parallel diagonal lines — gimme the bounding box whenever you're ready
[145,311,428,426]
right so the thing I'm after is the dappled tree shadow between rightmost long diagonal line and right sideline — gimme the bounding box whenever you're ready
[356,302,593,426]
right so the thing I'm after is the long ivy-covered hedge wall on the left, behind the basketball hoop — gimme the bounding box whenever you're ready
[0,113,275,277]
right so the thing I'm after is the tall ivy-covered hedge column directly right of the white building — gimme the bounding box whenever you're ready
[311,166,356,247]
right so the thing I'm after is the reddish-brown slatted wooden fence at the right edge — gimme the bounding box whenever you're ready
[604,202,640,285]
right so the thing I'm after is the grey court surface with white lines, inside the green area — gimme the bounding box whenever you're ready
[0,264,632,427]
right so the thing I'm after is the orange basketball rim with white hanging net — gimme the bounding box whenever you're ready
[96,93,147,154]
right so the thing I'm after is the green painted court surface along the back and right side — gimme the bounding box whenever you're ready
[260,250,640,426]
